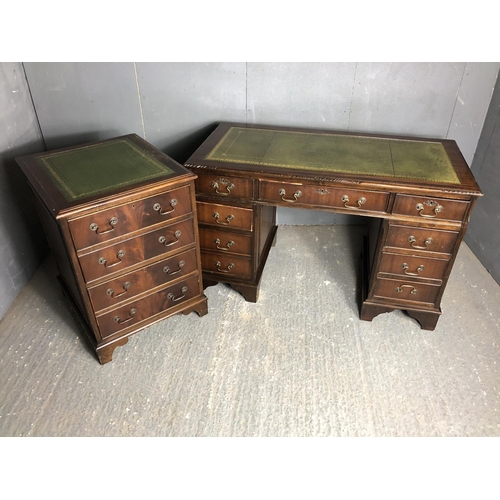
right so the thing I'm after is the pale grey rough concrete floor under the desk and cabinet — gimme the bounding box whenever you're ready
[0,226,500,437]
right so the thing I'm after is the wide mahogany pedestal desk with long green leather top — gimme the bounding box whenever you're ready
[185,123,482,330]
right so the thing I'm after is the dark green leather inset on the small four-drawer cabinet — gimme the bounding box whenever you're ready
[38,139,173,201]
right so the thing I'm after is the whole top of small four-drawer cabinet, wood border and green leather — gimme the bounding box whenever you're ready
[16,134,192,212]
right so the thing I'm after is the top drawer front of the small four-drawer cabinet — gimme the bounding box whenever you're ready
[69,186,192,250]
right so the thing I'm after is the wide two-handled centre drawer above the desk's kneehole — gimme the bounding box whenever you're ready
[259,180,389,212]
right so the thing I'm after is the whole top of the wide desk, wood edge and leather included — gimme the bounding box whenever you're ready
[186,123,481,195]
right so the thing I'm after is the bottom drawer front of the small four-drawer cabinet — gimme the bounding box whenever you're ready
[96,275,200,338]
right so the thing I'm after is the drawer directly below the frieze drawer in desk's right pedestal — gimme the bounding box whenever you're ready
[386,224,458,255]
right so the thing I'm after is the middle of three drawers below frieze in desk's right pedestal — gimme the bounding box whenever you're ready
[379,252,449,280]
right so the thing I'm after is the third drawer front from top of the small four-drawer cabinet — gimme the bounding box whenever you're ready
[88,248,197,311]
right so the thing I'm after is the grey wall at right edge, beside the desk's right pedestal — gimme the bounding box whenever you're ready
[465,75,500,283]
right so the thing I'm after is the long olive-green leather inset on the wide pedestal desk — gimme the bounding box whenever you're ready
[205,127,460,184]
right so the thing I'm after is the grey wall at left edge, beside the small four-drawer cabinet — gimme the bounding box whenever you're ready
[0,63,47,318]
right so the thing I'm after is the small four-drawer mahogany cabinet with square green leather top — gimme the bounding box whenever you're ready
[17,134,207,363]
